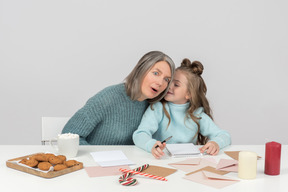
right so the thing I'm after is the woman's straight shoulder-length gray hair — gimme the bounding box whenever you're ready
[125,51,175,104]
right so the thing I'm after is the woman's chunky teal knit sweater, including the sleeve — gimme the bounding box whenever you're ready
[62,83,148,145]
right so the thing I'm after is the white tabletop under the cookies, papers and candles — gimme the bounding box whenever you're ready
[0,145,288,192]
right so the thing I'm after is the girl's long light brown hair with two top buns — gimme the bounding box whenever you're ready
[162,59,213,145]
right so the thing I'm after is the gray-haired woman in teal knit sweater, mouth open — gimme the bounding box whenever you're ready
[62,51,175,145]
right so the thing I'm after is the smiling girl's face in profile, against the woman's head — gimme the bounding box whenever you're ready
[164,71,190,104]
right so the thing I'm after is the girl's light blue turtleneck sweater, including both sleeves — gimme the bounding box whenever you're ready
[133,102,231,153]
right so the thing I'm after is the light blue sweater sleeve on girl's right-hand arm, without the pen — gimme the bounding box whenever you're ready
[199,112,231,149]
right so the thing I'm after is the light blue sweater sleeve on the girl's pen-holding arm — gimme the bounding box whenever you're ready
[133,102,164,153]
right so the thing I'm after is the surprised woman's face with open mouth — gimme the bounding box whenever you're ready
[138,61,171,101]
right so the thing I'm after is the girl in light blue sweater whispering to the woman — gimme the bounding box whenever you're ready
[133,59,231,158]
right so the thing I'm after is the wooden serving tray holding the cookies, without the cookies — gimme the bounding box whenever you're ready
[6,153,83,178]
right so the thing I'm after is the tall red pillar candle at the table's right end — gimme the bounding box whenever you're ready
[264,141,281,175]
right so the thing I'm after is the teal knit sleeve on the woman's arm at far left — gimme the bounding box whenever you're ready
[62,94,105,145]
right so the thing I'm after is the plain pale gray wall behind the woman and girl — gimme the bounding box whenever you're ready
[0,0,288,145]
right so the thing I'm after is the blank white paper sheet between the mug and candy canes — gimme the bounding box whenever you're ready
[90,150,134,167]
